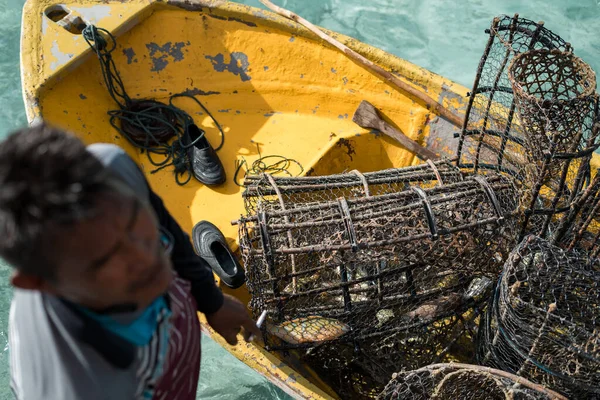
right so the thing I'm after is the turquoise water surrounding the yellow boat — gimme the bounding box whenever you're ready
[0,0,600,399]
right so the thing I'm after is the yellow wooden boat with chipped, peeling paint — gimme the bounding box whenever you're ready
[21,0,600,399]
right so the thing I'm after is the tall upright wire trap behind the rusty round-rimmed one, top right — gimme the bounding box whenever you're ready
[456,14,571,180]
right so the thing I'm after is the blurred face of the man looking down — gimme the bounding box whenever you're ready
[48,195,172,310]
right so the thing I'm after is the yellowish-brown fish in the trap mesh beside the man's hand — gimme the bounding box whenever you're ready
[267,315,350,344]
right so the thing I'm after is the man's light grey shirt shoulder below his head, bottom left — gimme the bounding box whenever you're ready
[9,289,137,399]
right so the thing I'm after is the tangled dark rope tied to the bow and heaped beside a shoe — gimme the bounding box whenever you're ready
[82,25,225,185]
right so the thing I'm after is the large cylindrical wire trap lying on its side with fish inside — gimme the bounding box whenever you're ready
[238,175,516,348]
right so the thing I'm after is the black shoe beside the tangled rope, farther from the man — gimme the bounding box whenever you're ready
[183,124,226,185]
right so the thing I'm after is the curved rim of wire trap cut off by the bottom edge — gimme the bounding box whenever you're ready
[377,363,566,400]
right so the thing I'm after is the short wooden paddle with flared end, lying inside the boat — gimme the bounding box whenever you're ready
[352,100,440,161]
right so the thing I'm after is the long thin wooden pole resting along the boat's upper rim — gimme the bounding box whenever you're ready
[260,0,463,128]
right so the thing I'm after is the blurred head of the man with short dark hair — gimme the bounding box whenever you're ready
[0,125,171,310]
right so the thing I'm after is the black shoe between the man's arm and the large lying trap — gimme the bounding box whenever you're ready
[192,221,246,289]
